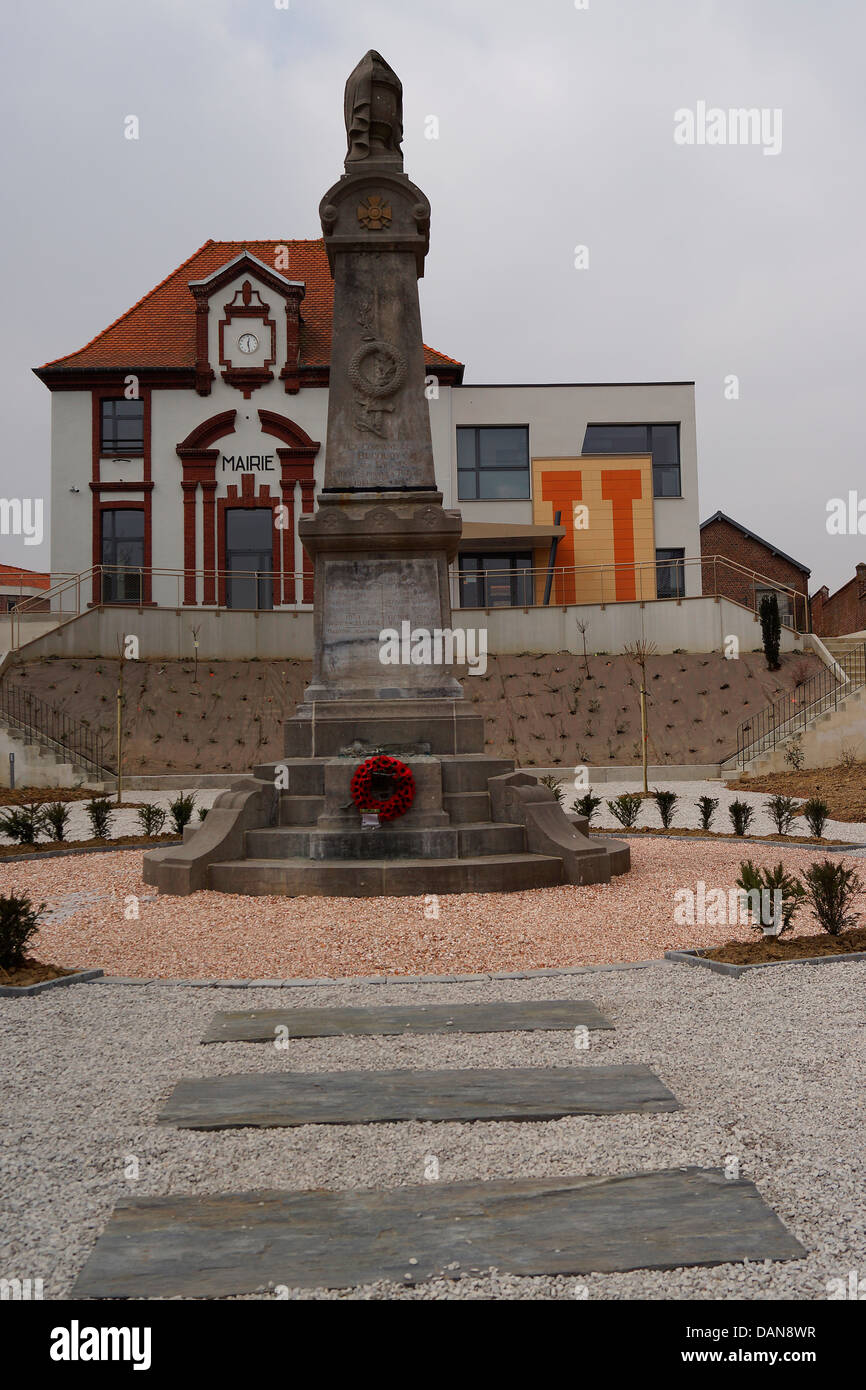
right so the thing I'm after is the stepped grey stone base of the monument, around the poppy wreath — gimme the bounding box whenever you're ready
[143,701,630,898]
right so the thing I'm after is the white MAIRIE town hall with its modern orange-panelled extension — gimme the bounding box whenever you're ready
[36,240,702,610]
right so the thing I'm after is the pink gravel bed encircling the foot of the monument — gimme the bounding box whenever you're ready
[0,840,866,980]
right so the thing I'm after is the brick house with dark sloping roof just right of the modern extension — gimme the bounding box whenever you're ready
[701,512,810,632]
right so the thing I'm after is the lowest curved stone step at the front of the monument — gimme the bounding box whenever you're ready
[207,831,563,898]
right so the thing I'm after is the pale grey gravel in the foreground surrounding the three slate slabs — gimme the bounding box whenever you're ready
[0,963,866,1300]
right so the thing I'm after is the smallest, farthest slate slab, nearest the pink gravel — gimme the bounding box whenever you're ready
[202,999,613,1043]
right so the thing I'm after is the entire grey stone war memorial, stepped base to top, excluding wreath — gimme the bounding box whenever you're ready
[145,53,630,897]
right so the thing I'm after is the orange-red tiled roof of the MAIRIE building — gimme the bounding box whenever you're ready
[38,238,460,373]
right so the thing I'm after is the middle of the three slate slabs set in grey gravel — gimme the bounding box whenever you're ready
[160,1065,680,1130]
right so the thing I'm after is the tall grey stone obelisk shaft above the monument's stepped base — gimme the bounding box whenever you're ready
[293,51,474,753]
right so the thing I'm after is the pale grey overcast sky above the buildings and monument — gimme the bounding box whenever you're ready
[0,0,866,591]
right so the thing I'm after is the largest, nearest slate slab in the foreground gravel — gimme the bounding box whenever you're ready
[71,1168,806,1298]
